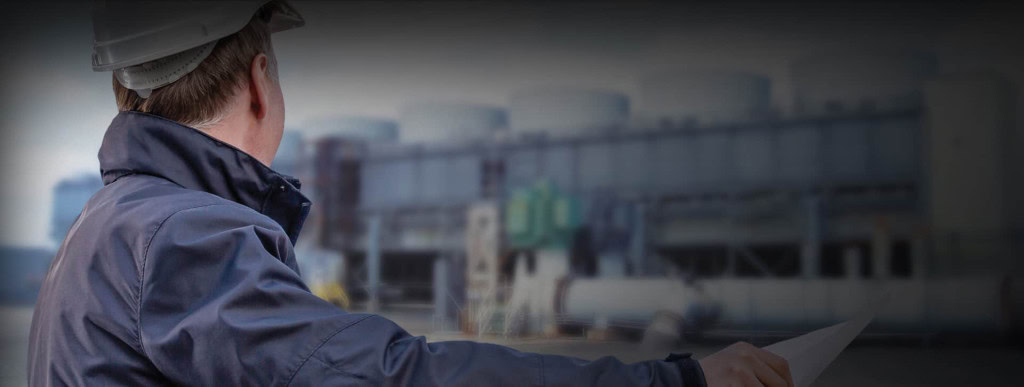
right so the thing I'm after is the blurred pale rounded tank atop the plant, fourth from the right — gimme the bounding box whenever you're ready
[399,101,508,143]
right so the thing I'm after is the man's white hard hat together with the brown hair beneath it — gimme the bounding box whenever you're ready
[93,0,304,128]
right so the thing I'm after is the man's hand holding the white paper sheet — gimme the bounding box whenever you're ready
[698,342,793,387]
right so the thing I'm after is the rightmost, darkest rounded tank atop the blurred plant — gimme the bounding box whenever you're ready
[792,50,936,116]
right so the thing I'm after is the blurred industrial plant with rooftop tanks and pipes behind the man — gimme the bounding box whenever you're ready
[262,52,1024,341]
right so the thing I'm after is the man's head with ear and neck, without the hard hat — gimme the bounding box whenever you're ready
[113,6,285,165]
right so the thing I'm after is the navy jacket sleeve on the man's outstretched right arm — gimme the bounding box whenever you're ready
[138,205,703,387]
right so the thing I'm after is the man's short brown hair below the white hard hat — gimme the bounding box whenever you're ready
[114,9,278,129]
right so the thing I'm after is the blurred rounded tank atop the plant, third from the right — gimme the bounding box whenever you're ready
[509,88,630,137]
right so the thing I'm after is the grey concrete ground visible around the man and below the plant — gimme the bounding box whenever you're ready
[0,307,1024,387]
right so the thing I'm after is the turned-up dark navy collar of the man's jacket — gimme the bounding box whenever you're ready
[99,112,310,245]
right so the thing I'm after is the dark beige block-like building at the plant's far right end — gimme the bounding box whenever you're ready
[925,74,1024,274]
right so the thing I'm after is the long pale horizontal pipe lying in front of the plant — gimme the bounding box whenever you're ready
[555,276,1014,334]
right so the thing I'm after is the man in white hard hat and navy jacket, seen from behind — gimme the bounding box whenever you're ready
[29,1,792,386]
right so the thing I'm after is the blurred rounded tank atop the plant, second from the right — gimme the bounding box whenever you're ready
[640,70,771,125]
